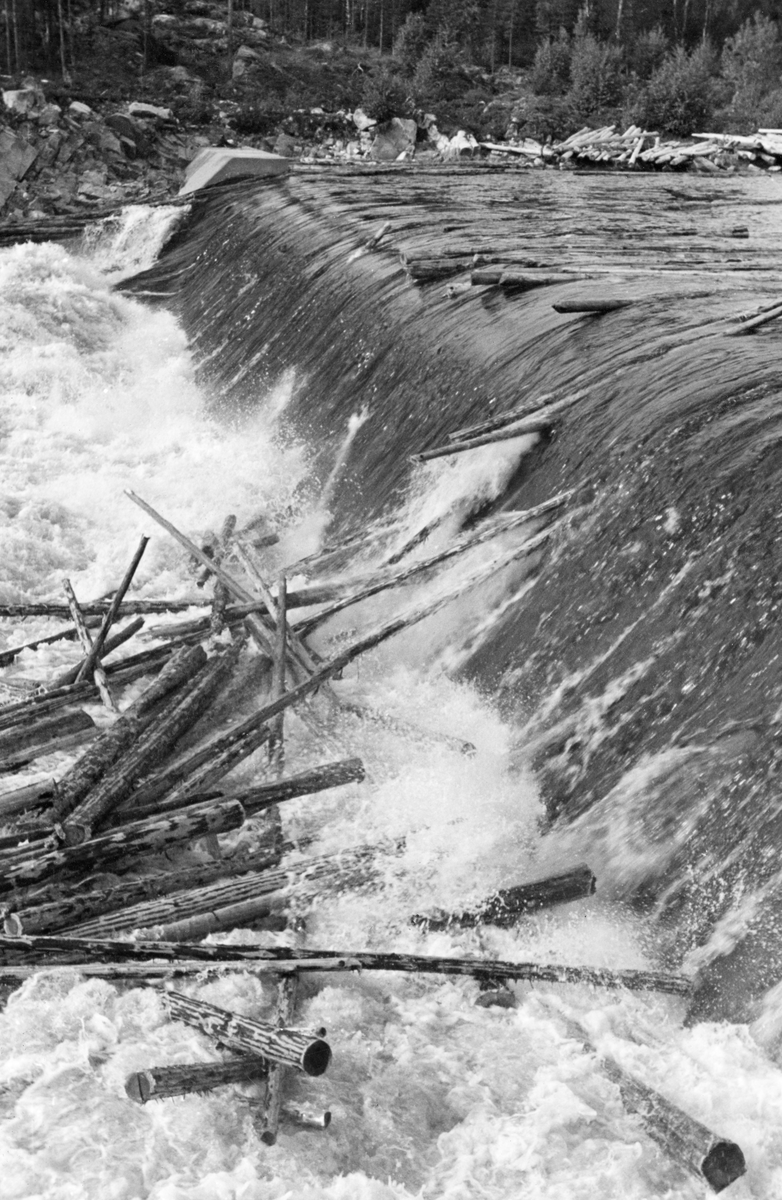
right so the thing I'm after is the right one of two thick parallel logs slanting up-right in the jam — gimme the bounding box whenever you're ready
[62,642,243,846]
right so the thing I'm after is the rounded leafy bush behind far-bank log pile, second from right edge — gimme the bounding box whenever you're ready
[632,46,715,137]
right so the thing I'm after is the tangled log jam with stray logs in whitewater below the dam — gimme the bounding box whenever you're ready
[0,482,742,1186]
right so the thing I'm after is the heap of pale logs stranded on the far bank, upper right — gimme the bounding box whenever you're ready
[481,125,782,173]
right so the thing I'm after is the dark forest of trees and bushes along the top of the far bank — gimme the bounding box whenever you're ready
[0,0,782,138]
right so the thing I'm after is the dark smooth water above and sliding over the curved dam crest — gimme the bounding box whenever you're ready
[124,168,782,1018]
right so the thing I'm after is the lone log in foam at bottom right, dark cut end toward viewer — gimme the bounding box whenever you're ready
[557,1010,746,1192]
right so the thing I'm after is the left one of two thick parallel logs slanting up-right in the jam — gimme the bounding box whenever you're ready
[54,646,206,821]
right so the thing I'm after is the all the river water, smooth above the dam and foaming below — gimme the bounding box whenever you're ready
[0,168,782,1200]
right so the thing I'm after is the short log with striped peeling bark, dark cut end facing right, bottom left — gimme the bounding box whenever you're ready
[166,991,331,1075]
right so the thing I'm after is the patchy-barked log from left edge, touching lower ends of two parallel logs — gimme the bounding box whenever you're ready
[0,800,245,893]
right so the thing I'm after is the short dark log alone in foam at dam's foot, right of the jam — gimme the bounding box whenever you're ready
[410,865,597,930]
